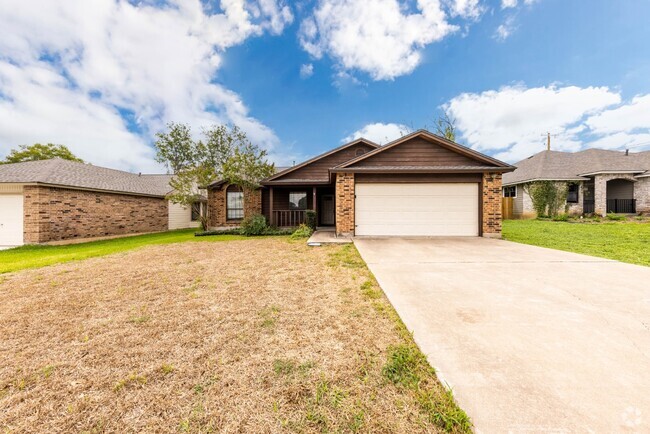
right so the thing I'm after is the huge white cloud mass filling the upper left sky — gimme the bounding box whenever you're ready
[0,0,293,170]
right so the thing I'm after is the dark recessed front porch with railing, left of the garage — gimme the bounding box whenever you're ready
[265,184,336,227]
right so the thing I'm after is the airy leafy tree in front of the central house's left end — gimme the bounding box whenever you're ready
[155,123,274,229]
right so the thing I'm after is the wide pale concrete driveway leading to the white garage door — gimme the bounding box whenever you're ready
[354,238,650,433]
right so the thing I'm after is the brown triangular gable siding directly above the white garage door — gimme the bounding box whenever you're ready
[350,137,476,167]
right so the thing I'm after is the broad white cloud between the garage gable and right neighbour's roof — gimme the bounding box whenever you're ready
[444,86,621,161]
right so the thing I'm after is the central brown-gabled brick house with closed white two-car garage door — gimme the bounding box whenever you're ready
[208,130,515,237]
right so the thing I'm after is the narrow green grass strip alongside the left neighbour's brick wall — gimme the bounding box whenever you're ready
[0,229,246,274]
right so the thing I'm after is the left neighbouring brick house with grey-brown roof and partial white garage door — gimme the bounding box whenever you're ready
[0,158,206,247]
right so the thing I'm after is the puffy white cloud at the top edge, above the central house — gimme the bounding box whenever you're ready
[299,0,456,80]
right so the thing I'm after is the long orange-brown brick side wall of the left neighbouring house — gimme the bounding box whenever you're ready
[23,186,169,244]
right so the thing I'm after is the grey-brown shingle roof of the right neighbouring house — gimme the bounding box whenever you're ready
[503,149,650,184]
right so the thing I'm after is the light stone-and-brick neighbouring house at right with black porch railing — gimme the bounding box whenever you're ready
[503,149,650,218]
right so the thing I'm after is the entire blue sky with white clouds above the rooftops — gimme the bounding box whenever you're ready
[0,0,650,171]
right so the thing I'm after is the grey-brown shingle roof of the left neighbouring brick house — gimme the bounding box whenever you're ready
[0,158,172,196]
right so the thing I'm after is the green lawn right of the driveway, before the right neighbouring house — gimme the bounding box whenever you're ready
[503,220,650,266]
